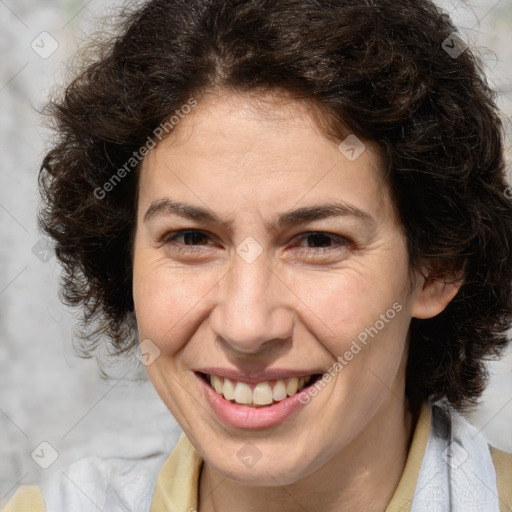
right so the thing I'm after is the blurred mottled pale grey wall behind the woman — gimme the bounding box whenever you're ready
[0,0,512,506]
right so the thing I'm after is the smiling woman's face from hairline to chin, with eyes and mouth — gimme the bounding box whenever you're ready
[133,94,444,485]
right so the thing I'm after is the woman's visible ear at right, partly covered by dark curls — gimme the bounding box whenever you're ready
[411,266,464,318]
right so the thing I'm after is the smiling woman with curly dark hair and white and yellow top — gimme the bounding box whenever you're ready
[7,0,512,512]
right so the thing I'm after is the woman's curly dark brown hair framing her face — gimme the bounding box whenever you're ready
[39,0,512,410]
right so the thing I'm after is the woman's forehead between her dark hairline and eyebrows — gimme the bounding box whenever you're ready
[139,93,394,229]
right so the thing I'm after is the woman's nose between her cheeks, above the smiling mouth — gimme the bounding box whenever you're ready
[210,252,293,354]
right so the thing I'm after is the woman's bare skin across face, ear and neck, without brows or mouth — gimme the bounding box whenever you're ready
[133,91,458,512]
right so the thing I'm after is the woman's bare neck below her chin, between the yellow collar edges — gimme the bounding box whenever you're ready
[199,394,415,512]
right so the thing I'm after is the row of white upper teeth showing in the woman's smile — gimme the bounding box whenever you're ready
[208,375,311,405]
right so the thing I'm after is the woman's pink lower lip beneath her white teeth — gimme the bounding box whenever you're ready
[198,377,308,430]
